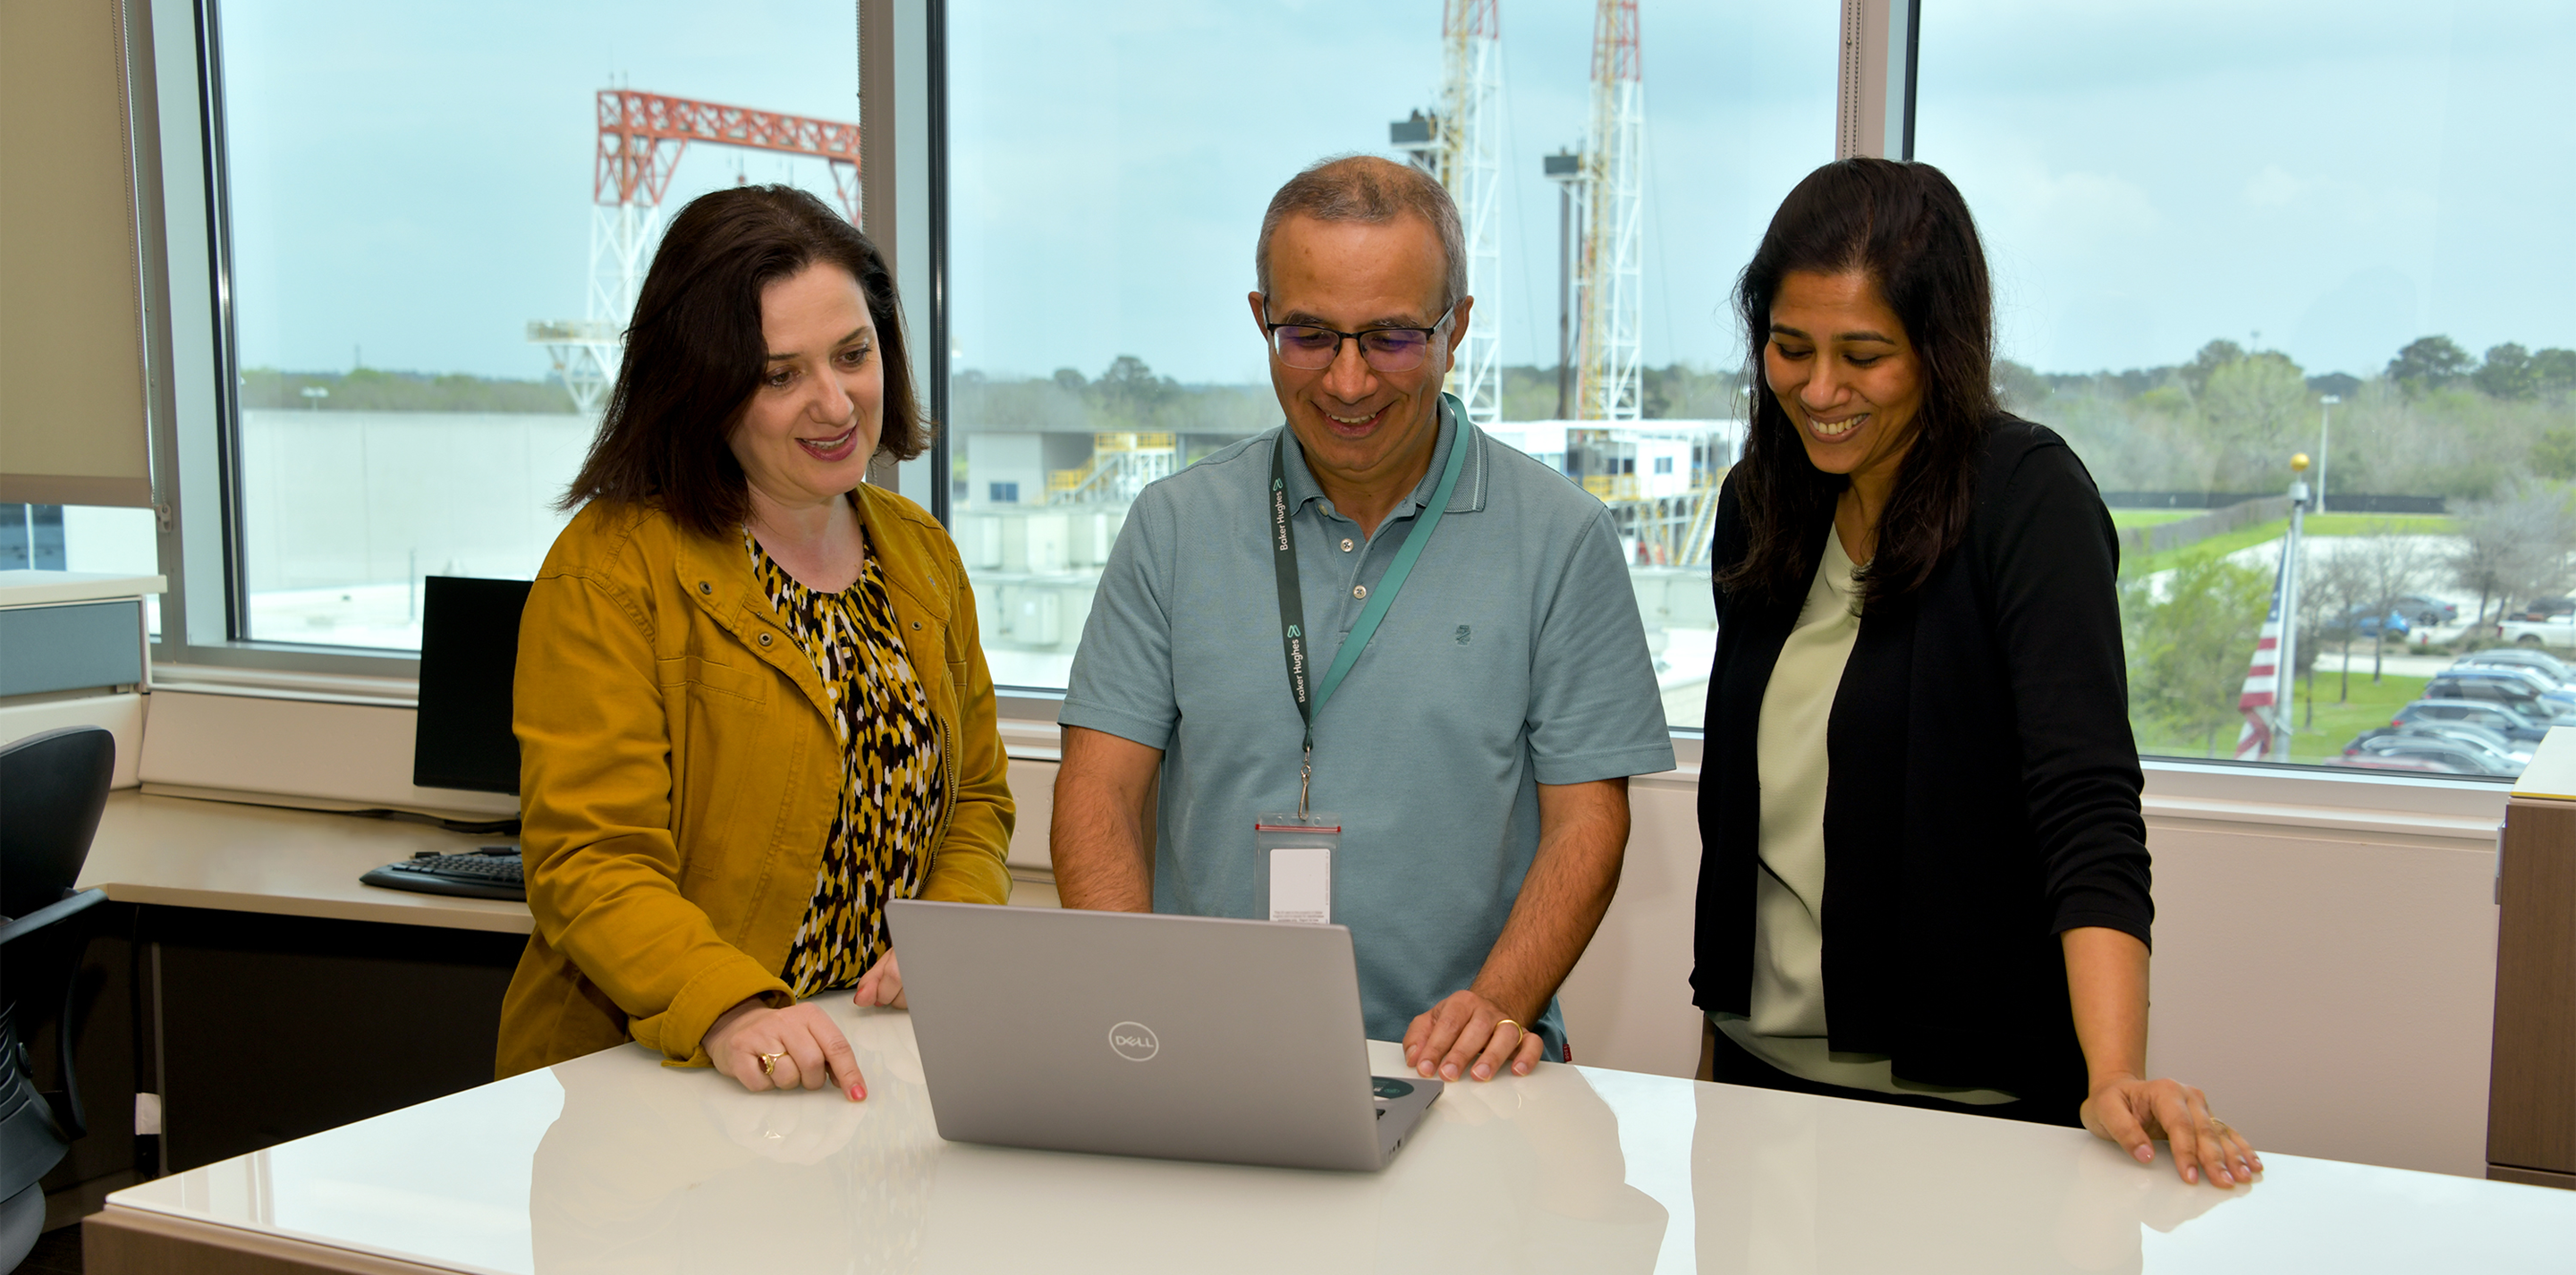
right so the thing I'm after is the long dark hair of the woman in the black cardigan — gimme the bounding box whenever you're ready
[1718,157,1996,605]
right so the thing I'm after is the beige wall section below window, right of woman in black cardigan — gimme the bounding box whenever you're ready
[2148,816,2496,1178]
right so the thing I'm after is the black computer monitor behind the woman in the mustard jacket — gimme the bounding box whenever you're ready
[412,574,528,793]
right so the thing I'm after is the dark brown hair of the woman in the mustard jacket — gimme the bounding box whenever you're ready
[556,185,930,536]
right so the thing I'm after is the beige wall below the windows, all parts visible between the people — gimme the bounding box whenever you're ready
[141,690,2501,1178]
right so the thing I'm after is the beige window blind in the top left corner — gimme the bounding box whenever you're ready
[0,0,152,505]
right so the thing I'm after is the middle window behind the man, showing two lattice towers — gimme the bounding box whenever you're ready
[945,0,1839,726]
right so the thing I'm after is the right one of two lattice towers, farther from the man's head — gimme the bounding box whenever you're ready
[1574,0,1646,430]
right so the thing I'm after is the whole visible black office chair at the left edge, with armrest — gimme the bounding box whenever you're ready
[0,726,116,1270]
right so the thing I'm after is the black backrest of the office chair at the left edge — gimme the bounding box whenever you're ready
[0,726,116,917]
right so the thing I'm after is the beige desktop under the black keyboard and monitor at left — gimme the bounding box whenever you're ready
[80,790,536,935]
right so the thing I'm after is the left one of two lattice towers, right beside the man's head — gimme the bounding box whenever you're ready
[1435,0,1502,425]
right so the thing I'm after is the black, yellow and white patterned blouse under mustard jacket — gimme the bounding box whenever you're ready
[741,530,948,997]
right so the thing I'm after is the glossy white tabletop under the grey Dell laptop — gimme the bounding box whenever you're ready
[108,997,2576,1275]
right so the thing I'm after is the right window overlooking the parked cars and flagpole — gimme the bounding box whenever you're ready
[1914,0,2576,773]
